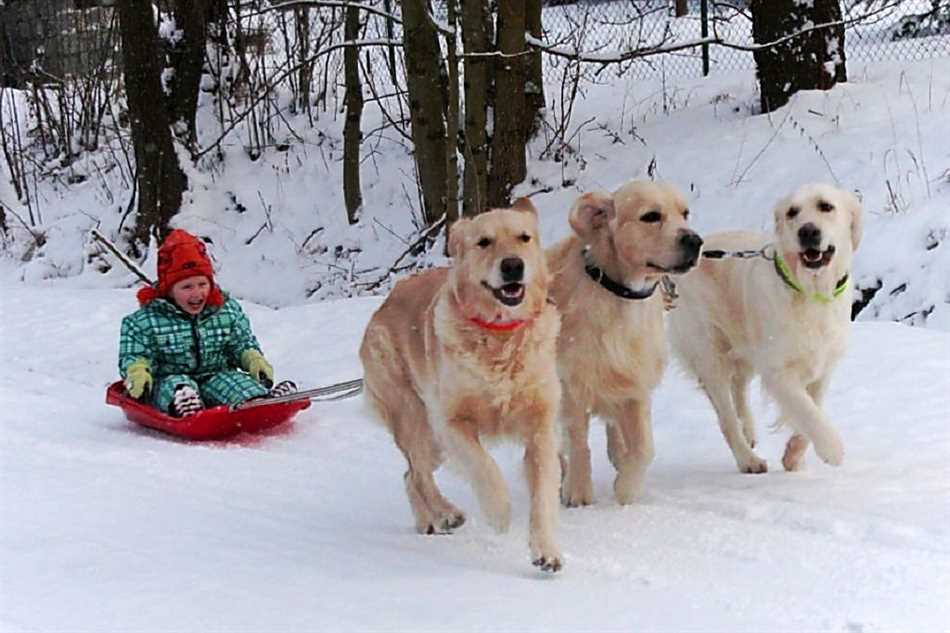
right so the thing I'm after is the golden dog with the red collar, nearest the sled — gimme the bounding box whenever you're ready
[360,198,562,572]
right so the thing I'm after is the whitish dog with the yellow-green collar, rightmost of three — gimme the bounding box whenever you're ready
[670,184,861,473]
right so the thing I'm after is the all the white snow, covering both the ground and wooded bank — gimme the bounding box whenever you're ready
[0,9,950,633]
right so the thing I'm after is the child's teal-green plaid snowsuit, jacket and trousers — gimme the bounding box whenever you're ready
[119,295,268,412]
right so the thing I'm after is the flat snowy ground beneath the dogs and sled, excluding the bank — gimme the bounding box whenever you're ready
[0,280,950,633]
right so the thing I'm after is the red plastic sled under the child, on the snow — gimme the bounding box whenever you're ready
[106,380,310,440]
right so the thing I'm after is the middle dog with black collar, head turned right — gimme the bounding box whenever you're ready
[547,182,703,506]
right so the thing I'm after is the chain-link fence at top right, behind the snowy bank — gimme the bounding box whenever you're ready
[542,0,950,80]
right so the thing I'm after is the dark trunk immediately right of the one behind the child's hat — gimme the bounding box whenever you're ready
[169,0,212,148]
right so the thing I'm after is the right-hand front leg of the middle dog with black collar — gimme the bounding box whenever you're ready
[608,397,655,505]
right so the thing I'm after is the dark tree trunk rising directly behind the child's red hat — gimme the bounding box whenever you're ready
[116,0,188,250]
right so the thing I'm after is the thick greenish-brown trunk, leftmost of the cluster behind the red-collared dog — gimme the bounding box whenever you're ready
[402,0,448,226]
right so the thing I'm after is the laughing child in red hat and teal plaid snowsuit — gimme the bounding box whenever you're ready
[119,229,296,417]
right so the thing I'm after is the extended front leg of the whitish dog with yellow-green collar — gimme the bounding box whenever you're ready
[762,372,844,466]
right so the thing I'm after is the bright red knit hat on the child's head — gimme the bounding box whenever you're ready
[137,229,224,306]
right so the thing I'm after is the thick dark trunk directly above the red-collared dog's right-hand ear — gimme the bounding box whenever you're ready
[488,0,527,207]
